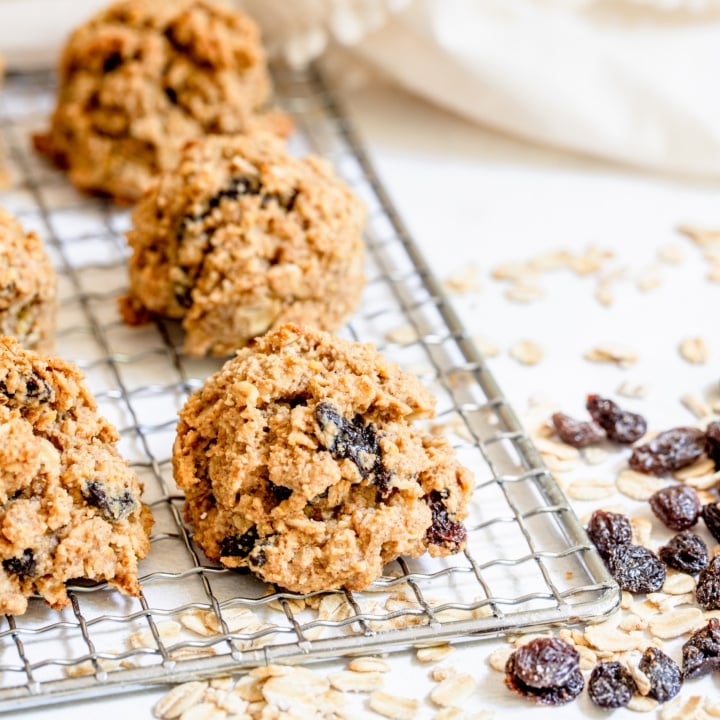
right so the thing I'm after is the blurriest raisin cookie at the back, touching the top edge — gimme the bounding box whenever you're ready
[34,0,291,202]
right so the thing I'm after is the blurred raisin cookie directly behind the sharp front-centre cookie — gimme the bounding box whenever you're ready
[123,134,365,356]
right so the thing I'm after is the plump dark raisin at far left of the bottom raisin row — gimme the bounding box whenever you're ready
[515,637,580,688]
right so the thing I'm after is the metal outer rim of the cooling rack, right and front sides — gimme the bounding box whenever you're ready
[0,66,619,713]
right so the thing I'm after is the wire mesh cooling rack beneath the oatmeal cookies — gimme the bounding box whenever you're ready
[0,69,618,712]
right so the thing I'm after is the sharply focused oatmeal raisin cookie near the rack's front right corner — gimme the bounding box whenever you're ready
[173,324,472,593]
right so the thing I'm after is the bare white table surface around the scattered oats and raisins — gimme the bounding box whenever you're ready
[17,74,720,720]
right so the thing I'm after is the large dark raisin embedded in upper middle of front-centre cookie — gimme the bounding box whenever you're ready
[315,402,390,493]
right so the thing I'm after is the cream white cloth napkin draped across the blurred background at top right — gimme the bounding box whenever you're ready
[239,0,720,178]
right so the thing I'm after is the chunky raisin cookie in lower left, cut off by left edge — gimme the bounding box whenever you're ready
[0,338,152,614]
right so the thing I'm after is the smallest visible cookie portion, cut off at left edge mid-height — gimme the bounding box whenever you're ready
[0,207,57,352]
